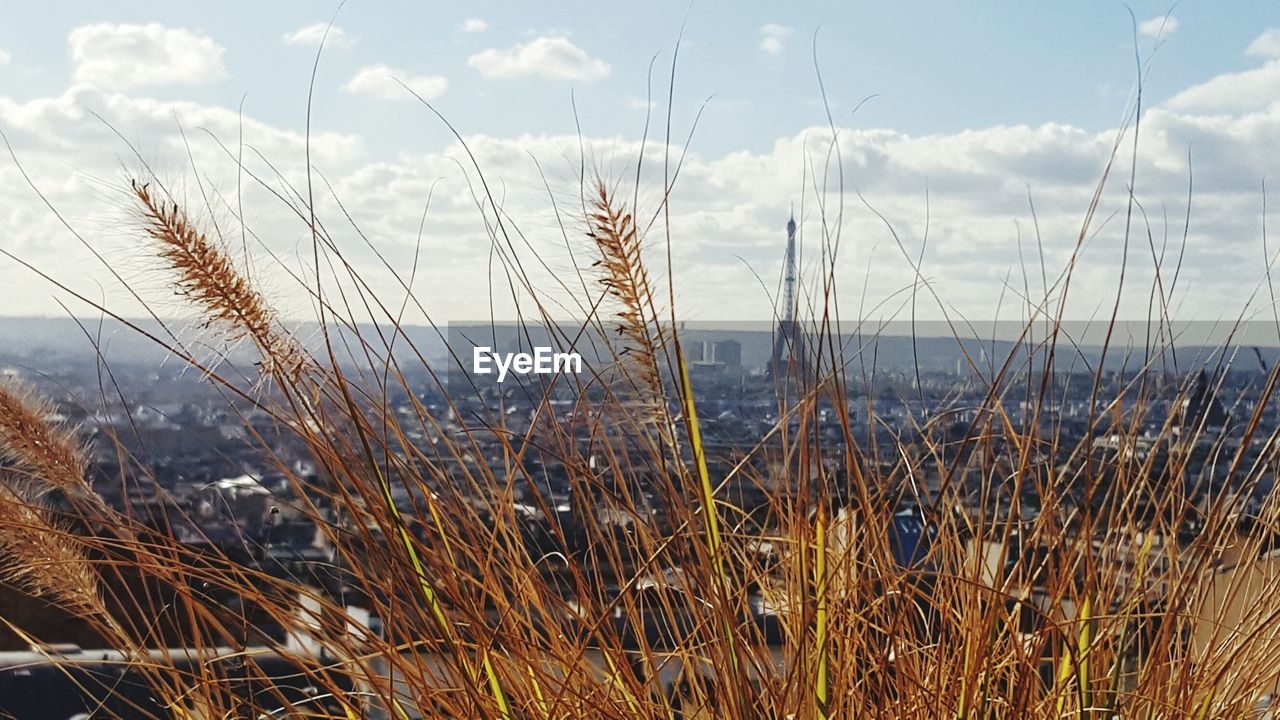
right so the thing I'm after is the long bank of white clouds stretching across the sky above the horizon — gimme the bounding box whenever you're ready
[10,29,1280,320]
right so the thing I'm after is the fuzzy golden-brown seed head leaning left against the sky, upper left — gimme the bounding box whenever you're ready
[132,181,307,380]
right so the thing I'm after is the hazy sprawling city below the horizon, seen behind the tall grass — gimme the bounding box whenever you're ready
[0,274,1280,712]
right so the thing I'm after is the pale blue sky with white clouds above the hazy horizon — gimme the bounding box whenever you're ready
[0,0,1280,322]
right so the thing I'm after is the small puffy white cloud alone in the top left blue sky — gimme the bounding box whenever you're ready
[67,23,227,90]
